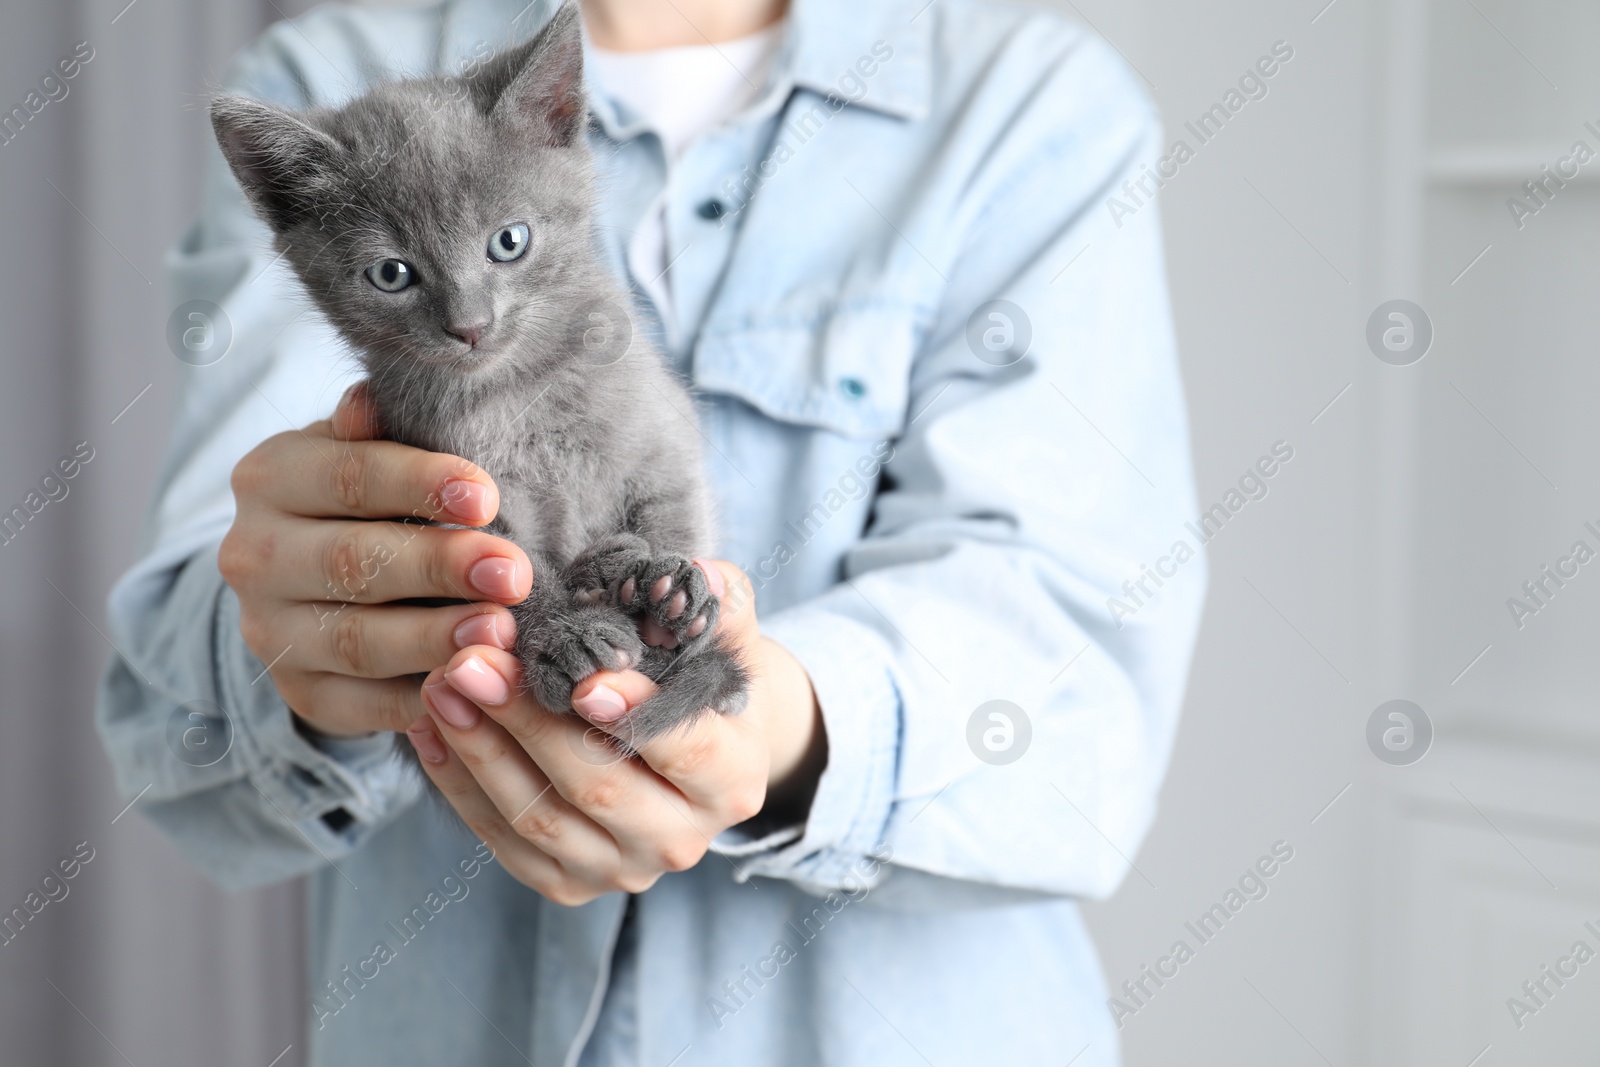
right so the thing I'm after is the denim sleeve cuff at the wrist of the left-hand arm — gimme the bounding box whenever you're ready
[214,575,421,854]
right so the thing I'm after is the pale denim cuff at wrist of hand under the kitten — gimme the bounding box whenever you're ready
[712,605,902,891]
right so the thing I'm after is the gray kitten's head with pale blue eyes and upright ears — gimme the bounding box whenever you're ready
[211,3,594,381]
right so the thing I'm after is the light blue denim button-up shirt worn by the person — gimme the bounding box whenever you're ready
[99,0,1205,1067]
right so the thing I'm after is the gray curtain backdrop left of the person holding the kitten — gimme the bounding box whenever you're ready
[0,0,318,1067]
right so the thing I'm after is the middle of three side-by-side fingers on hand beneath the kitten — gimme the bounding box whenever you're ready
[422,673,621,885]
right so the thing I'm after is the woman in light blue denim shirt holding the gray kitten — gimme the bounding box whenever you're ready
[99,0,1203,1067]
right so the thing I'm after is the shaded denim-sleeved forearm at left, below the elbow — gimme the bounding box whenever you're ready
[96,550,416,888]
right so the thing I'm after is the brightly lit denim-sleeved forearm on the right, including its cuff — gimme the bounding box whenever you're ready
[718,544,1203,897]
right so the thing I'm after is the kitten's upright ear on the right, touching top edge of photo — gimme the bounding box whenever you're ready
[485,0,589,149]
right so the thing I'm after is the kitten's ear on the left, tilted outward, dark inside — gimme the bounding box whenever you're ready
[211,96,339,234]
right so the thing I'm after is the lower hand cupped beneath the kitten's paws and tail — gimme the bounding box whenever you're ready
[406,560,827,905]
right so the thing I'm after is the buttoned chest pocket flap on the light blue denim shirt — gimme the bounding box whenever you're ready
[693,304,917,440]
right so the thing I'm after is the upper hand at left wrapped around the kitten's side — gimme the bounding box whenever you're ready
[218,387,533,737]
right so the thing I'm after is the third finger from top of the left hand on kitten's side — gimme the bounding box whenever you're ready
[272,603,517,678]
